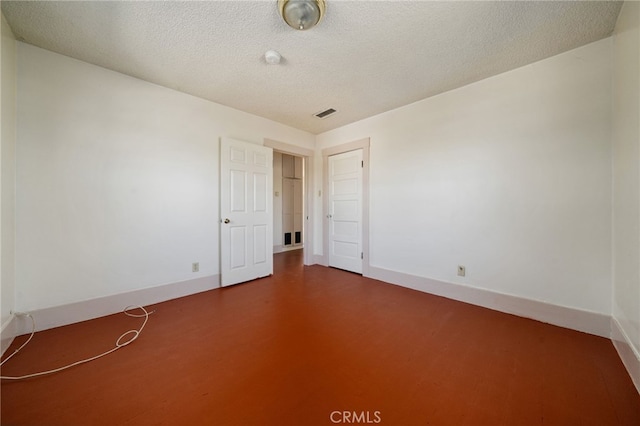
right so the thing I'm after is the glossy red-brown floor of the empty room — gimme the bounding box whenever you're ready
[1,251,640,426]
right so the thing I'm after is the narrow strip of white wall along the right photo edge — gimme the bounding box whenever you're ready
[613,2,640,384]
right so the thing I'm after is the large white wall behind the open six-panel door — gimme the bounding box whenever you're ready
[16,43,314,311]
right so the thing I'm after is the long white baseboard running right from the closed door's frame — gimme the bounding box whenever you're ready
[368,266,611,338]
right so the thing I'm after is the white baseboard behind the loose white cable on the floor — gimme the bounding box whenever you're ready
[13,275,220,343]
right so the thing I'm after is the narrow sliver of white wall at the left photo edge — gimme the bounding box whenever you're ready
[0,15,16,330]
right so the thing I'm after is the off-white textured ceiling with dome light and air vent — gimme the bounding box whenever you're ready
[2,0,621,133]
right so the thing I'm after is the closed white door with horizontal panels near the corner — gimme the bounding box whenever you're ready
[327,149,362,274]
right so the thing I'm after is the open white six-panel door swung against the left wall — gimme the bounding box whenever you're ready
[220,138,273,286]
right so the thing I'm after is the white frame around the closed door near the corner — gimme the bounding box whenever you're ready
[322,138,370,277]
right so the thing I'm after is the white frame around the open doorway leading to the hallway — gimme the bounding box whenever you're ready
[263,138,315,265]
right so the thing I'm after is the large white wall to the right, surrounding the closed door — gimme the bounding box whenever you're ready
[314,39,612,315]
